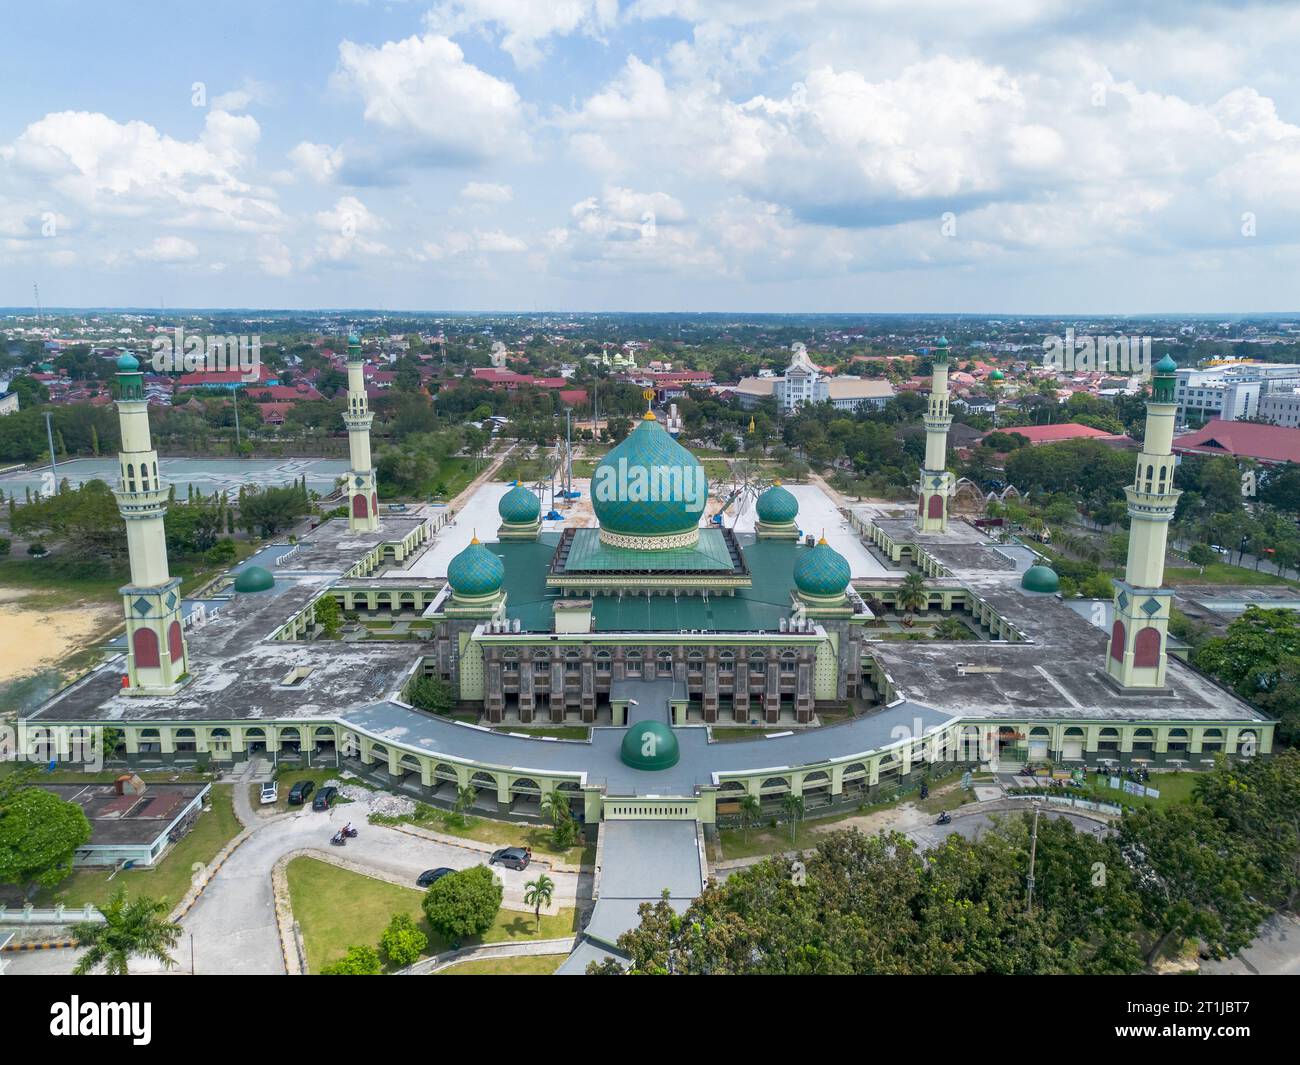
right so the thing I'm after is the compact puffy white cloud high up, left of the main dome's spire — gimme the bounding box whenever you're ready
[335,34,528,165]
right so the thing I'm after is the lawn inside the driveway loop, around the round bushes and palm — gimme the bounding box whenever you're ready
[286,858,577,973]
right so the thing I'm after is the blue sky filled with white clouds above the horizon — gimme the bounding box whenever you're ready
[0,0,1300,313]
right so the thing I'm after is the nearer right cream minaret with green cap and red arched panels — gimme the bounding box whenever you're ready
[1106,355,1182,688]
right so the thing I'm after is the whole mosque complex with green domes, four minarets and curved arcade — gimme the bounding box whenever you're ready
[20,337,1274,971]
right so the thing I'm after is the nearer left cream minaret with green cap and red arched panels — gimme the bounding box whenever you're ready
[113,355,190,696]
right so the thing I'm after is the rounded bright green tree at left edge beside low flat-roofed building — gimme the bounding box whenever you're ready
[0,787,91,888]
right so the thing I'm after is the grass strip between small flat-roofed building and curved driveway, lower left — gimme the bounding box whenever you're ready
[36,784,241,908]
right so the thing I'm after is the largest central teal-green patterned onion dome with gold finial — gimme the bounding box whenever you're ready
[592,414,709,549]
